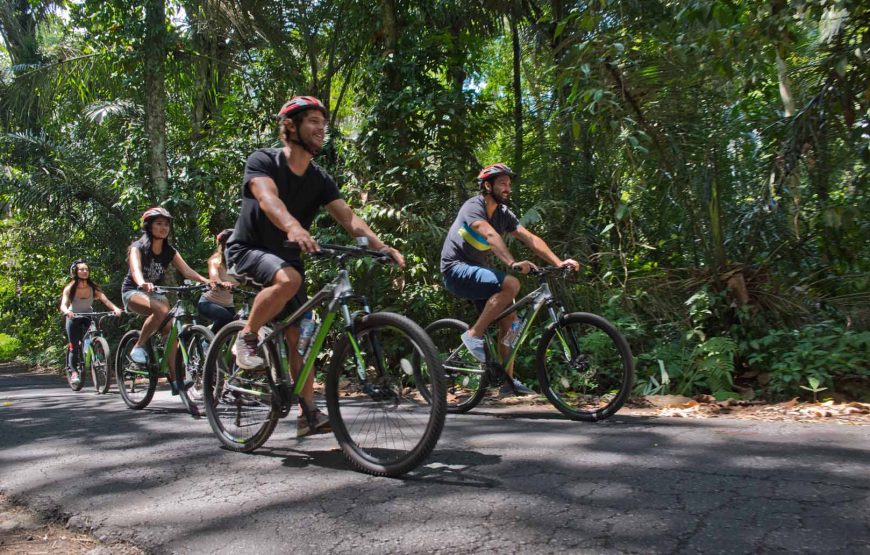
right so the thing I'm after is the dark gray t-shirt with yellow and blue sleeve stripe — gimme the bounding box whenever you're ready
[441,195,520,272]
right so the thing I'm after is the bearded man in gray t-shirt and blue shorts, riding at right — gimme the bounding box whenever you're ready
[441,164,580,394]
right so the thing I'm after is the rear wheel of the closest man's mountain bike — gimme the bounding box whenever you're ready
[202,321,280,453]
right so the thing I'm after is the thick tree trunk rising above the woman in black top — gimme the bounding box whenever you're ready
[145,0,169,202]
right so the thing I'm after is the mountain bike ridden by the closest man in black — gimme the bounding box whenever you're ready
[205,244,446,476]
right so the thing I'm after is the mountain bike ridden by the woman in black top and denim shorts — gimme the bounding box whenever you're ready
[115,284,214,417]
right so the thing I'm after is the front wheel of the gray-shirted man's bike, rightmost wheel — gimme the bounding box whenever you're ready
[537,312,634,422]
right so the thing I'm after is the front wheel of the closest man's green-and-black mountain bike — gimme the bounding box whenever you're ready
[326,312,446,476]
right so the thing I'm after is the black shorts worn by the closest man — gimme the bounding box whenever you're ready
[225,243,308,320]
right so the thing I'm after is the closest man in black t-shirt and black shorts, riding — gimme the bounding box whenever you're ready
[226,96,405,436]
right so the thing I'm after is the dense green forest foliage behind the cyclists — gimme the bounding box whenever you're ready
[0,0,870,397]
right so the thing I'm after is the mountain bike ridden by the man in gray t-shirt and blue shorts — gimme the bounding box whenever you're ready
[426,266,634,422]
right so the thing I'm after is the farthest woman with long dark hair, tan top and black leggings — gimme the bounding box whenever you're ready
[60,260,122,385]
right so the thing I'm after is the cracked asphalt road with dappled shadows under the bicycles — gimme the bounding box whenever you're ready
[0,368,870,554]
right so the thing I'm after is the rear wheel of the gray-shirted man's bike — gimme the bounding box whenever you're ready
[415,318,489,414]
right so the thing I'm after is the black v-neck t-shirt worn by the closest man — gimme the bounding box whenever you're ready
[227,148,341,257]
